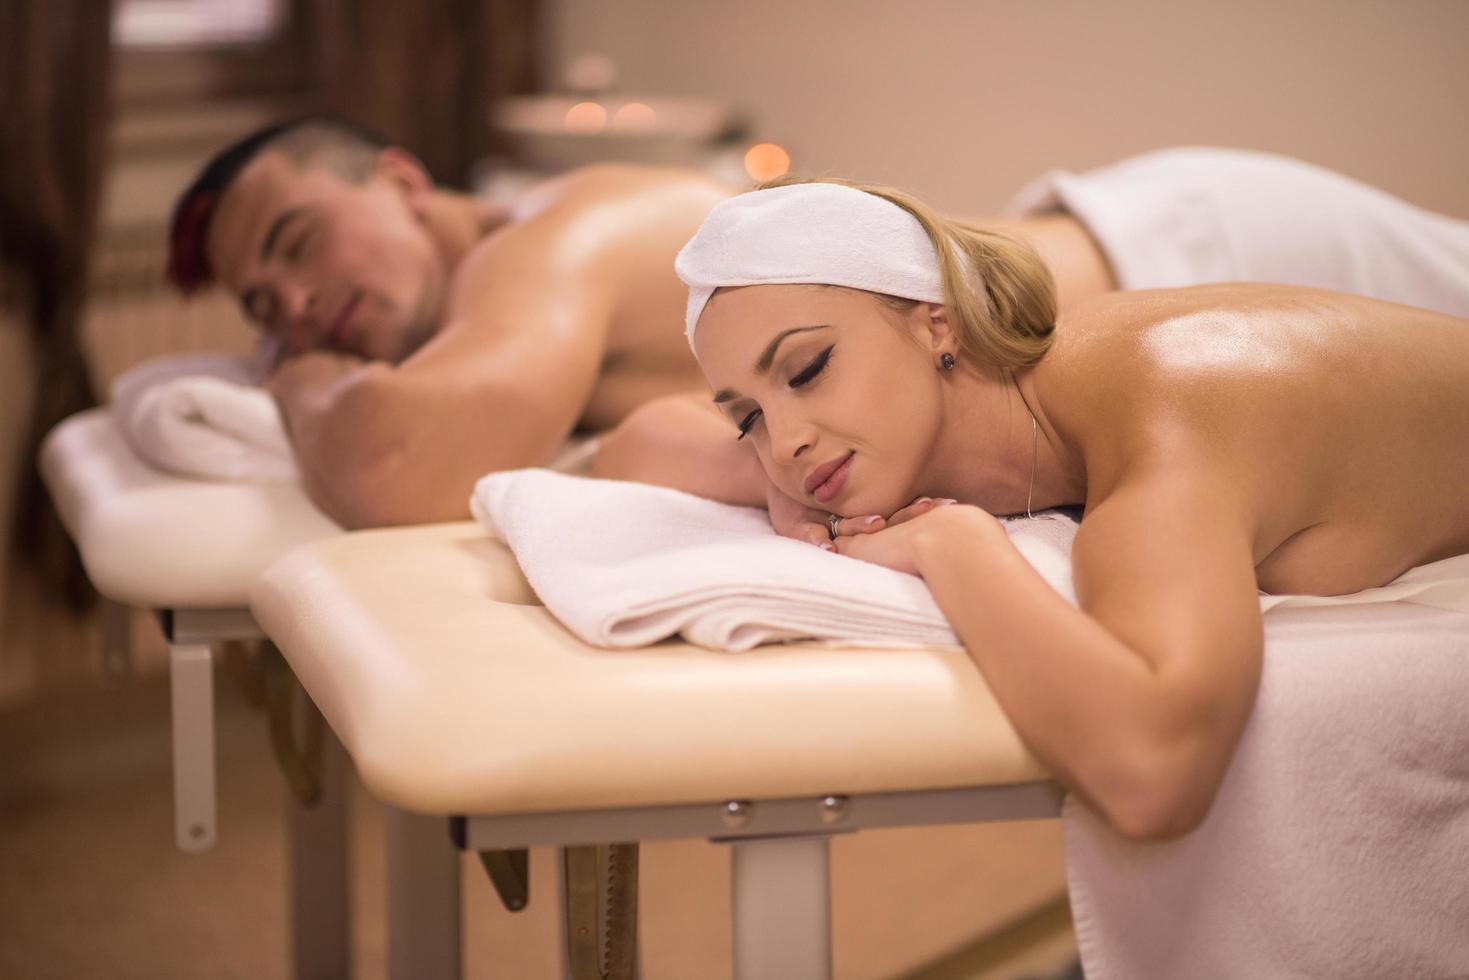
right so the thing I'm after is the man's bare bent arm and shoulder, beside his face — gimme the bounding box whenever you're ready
[272,239,613,527]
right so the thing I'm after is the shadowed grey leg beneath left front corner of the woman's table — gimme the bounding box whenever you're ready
[386,807,460,980]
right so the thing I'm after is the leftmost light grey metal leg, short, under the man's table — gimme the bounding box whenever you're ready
[169,642,217,854]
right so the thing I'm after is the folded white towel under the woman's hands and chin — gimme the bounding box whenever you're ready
[470,470,1075,649]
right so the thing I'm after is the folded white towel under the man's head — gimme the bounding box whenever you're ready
[112,354,300,483]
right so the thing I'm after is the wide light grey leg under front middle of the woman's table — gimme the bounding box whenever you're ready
[732,835,831,980]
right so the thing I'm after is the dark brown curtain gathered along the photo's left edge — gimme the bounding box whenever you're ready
[0,0,112,607]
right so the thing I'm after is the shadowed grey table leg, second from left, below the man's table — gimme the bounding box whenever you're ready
[286,730,351,980]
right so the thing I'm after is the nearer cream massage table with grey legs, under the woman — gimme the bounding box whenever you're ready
[251,522,1061,980]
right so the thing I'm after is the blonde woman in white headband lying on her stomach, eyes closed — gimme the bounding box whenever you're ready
[590,181,1469,837]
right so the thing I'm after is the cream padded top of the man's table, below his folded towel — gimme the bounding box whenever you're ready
[41,408,341,608]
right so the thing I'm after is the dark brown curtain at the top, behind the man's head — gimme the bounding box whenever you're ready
[295,0,538,187]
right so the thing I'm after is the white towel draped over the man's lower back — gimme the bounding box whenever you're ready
[1005,147,1469,316]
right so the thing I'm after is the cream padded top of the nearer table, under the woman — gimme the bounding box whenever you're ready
[251,522,1049,815]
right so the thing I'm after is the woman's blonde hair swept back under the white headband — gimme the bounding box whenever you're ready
[759,176,1056,369]
